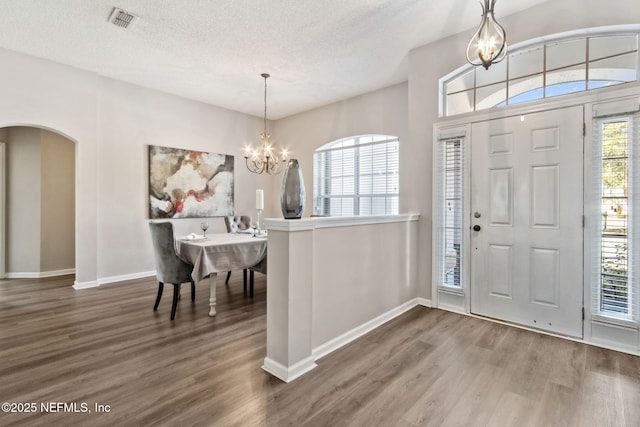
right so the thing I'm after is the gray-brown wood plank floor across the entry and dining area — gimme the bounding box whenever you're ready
[0,272,640,427]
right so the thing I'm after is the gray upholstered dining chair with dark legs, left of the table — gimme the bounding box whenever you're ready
[149,221,196,320]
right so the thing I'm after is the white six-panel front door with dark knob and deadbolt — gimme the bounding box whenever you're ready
[470,106,583,337]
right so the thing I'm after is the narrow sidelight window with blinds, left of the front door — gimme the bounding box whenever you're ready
[436,137,464,289]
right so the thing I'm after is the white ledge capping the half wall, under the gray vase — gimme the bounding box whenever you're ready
[264,213,420,232]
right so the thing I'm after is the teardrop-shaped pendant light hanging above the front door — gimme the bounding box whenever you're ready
[467,0,507,70]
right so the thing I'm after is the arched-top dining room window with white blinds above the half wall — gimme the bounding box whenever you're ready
[313,135,400,216]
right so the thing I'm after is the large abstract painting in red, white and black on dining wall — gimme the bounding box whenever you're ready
[149,145,233,219]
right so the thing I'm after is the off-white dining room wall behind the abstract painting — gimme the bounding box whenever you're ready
[97,80,269,278]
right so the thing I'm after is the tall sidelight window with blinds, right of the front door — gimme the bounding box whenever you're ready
[592,107,640,321]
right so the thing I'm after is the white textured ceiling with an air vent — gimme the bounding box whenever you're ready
[0,0,545,119]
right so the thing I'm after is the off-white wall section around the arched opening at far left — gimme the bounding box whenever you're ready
[0,50,99,281]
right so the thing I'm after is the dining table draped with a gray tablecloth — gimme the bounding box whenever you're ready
[176,233,267,316]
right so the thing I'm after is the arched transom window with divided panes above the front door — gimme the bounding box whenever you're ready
[441,32,639,116]
